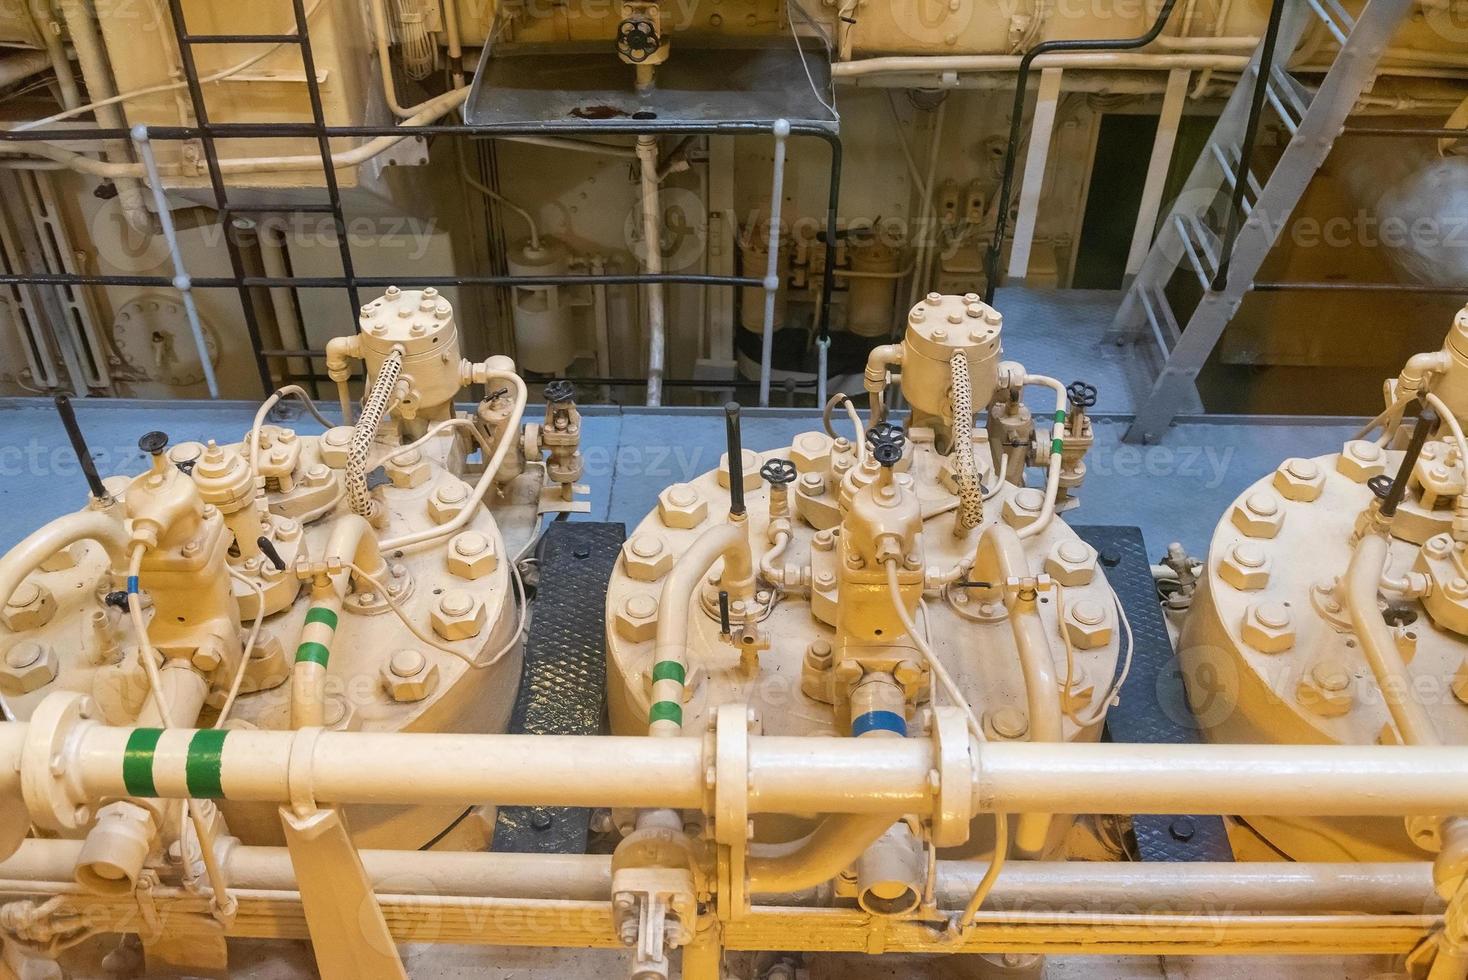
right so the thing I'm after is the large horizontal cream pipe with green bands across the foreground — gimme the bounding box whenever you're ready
[17,718,1468,817]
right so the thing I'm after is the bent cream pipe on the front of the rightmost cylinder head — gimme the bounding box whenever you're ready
[1345,534,1442,745]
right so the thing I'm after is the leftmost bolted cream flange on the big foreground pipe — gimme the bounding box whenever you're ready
[21,691,97,832]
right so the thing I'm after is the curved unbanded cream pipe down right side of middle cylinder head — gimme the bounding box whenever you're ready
[973,524,1066,858]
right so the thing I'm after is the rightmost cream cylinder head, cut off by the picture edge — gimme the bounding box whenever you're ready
[1161,303,1468,863]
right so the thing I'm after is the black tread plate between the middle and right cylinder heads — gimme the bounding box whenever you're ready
[1075,525,1233,861]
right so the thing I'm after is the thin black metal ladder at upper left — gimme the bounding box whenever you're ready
[160,0,361,395]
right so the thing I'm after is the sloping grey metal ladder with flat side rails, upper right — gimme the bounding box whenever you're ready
[1107,0,1414,442]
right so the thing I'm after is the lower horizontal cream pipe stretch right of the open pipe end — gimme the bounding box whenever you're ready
[939,861,1443,914]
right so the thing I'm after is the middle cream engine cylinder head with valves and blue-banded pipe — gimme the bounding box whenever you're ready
[608,293,1129,874]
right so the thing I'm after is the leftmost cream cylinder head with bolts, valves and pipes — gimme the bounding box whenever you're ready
[0,288,580,962]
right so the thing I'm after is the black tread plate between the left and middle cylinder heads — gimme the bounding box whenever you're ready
[490,521,627,854]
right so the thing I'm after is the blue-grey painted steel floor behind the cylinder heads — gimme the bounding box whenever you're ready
[0,289,1355,555]
